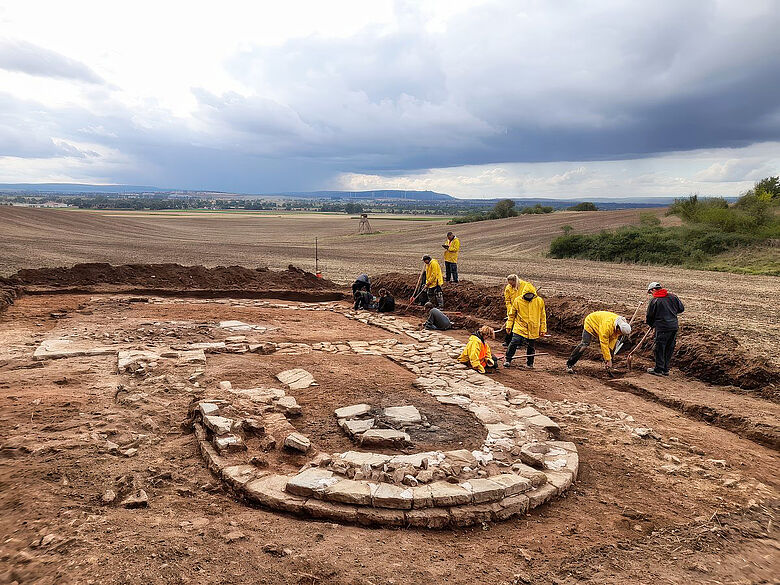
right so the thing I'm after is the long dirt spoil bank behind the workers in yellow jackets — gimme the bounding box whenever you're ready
[372,272,780,392]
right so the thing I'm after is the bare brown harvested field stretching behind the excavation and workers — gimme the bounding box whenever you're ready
[0,207,780,363]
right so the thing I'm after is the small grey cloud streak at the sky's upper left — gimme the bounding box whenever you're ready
[0,40,103,84]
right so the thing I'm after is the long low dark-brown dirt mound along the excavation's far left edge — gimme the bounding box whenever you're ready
[6,263,336,290]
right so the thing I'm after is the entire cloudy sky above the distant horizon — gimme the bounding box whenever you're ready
[0,0,780,198]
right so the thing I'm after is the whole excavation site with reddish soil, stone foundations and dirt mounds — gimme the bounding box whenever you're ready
[0,264,780,584]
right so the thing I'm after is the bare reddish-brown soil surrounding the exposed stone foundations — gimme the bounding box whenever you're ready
[0,295,780,585]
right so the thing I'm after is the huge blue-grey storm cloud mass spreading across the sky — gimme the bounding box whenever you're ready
[0,0,780,191]
